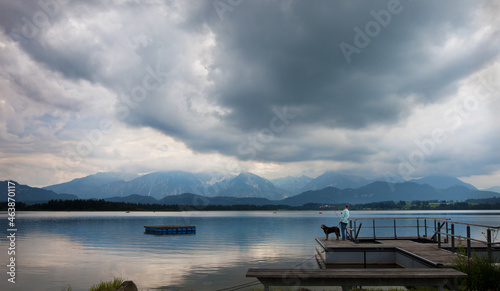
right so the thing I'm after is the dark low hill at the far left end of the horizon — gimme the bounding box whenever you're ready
[0,181,78,204]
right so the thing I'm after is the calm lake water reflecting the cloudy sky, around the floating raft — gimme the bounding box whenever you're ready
[0,211,500,291]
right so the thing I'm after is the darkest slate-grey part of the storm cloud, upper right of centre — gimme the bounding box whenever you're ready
[206,1,496,129]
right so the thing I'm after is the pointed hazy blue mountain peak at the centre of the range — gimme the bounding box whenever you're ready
[217,172,287,200]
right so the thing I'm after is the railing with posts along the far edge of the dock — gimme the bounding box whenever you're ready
[348,217,500,258]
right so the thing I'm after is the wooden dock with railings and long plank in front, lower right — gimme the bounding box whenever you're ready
[247,217,500,290]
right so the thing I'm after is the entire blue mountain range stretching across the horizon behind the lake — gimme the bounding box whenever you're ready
[3,171,498,206]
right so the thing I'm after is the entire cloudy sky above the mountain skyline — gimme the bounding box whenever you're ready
[0,0,500,188]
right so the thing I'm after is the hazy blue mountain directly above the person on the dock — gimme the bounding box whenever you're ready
[301,171,372,192]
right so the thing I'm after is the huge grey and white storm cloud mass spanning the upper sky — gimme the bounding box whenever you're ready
[0,0,500,185]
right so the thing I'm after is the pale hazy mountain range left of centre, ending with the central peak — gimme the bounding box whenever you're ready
[44,171,290,199]
